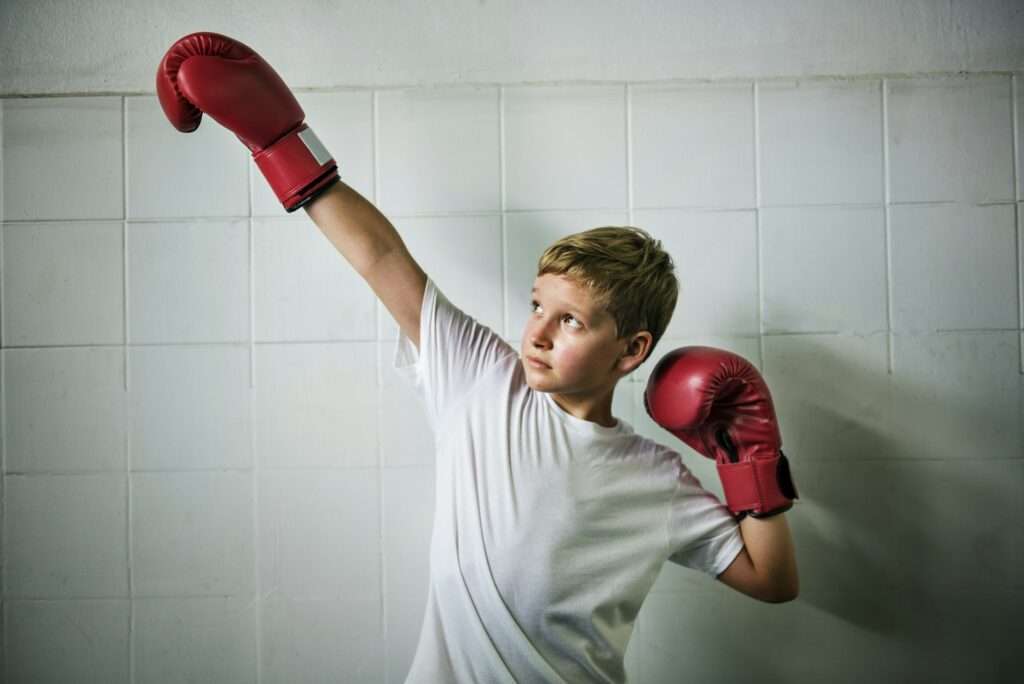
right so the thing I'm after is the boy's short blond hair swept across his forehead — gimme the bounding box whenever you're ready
[537,225,679,362]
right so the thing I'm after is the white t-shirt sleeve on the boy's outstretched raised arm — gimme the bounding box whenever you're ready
[392,276,517,426]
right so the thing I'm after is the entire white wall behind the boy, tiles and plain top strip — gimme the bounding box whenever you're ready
[0,1,1024,683]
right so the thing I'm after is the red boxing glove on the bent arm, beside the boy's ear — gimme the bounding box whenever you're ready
[643,347,798,519]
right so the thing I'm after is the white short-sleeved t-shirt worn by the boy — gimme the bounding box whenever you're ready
[393,279,742,684]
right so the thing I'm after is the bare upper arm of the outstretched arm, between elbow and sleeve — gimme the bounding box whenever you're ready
[365,245,427,350]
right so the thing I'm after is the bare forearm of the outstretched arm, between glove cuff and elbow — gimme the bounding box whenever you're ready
[305,181,403,275]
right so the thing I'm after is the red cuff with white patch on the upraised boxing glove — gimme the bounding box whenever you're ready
[253,124,339,212]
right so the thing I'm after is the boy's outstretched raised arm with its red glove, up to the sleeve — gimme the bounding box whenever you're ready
[157,32,427,347]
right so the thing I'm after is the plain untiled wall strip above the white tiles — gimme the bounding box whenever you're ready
[6,0,1024,96]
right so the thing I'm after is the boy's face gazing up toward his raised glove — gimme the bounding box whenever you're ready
[521,273,632,399]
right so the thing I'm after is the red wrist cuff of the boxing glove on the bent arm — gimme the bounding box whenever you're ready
[718,450,799,519]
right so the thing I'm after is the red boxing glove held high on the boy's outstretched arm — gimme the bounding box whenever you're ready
[157,33,339,212]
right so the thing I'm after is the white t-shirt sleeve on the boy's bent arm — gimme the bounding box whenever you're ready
[669,460,743,578]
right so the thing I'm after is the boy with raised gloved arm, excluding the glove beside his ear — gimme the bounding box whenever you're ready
[157,33,798,682]
